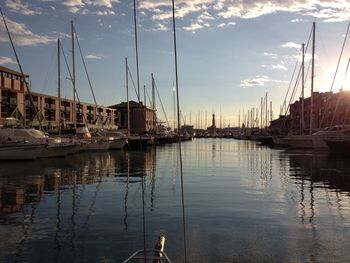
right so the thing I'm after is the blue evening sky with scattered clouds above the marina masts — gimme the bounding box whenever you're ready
[0,0,350,127]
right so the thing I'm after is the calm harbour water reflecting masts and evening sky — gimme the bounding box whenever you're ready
[0,139,350,262]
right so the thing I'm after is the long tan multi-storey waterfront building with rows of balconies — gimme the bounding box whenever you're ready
[0,66,118,130]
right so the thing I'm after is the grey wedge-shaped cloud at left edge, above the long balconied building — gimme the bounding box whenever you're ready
[0,18,56,46]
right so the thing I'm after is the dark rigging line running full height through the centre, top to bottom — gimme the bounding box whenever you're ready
[172,0,187,263]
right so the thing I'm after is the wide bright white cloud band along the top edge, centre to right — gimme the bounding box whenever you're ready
[139,0,350,22]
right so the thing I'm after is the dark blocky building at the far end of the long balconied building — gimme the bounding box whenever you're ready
[110,101,156,134]
